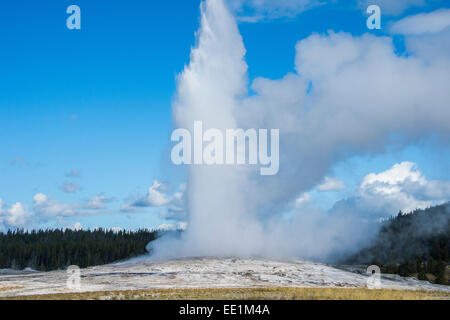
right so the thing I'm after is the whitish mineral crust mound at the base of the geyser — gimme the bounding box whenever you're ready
[0,258,450,297]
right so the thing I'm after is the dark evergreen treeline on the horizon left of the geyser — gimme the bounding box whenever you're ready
[0,229,157,271]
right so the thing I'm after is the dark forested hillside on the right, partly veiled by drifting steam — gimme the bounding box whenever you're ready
[345,203,450,285]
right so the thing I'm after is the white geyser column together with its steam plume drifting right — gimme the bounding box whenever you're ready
[152,0,450,260]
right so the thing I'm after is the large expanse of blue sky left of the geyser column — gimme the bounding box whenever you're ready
[0,1,198,230]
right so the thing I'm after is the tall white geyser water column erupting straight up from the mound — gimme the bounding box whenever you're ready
[170,0,262,255]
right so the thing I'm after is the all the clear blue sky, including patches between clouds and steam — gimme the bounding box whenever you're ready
[0,0,450,228]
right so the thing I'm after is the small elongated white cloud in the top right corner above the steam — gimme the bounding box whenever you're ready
[390,9,450,35]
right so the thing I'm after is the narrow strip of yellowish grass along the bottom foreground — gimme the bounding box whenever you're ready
[6,288,450,300]
